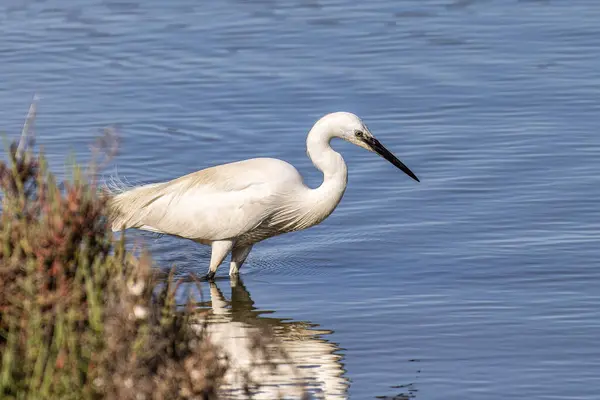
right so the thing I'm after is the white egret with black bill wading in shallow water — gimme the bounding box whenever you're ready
[109,112,419,280]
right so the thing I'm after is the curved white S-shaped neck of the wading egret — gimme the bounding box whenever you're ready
[306,123,348,223]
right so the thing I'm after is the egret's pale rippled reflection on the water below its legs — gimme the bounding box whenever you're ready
[189,278,348,399]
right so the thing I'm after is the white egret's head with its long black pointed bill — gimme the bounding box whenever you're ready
[317,112,420,182]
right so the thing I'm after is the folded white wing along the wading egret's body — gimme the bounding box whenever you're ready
[111,158,303,241]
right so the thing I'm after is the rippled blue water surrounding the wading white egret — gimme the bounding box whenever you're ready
[0,0,600,400]
